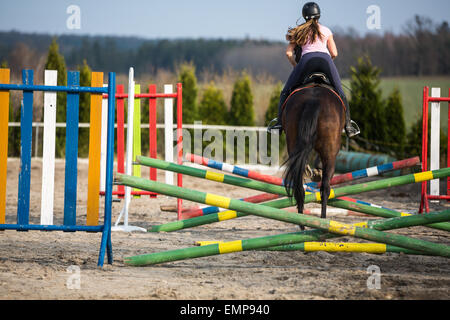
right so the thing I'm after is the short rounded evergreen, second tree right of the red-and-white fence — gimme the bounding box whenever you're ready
[198,83,227,125]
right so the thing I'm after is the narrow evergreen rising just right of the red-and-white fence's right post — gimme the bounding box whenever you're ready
[175,63,198,124]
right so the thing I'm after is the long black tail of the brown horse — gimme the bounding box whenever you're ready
[284,100,320,210]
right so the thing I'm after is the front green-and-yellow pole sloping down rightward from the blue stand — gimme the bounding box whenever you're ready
[116,174,450,264]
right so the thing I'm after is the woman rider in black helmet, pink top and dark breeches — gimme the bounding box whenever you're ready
[268,2,359,137]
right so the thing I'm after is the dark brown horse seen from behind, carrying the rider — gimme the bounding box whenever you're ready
[282,84,345,229]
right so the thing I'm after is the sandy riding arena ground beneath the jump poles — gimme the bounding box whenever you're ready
[0,159,450,300]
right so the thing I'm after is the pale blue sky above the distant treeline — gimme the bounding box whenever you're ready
[0,0,450,41]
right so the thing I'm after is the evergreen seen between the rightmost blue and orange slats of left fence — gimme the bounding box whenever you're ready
[78,60,92,158]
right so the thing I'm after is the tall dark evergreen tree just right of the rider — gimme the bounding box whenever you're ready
[350,56,387,148]
